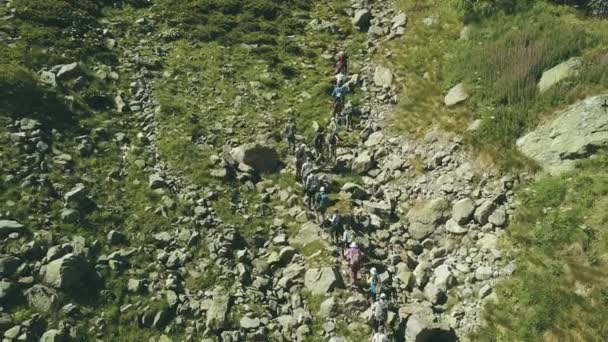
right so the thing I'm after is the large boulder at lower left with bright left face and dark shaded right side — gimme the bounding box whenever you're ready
[40,253,89,289]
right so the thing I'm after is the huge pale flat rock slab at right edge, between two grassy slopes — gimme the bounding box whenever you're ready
[517,94,608,175]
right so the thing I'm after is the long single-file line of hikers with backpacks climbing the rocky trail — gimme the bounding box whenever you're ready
[285,53,388,342]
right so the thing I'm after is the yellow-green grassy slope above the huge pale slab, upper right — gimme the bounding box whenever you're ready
[385,0,608,171]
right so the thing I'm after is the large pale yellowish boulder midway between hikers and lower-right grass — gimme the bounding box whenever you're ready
[407,198,449,241]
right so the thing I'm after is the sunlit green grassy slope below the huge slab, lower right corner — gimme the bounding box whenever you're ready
[474,156,608,341]
